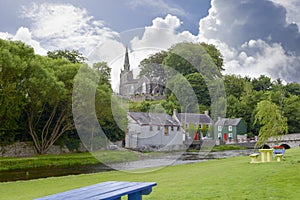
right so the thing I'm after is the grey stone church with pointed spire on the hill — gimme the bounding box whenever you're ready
[119,48,165,100]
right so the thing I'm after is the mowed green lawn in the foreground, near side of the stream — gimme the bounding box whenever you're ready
[0,148,300,200]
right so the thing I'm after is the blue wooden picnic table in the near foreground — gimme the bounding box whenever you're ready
[36,181,156,200]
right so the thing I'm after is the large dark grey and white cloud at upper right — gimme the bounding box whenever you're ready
[199,0,300,82]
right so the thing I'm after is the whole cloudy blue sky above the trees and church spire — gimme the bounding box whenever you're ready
[0,0,300,89]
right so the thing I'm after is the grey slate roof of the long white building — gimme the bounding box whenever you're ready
[128,112,180,126]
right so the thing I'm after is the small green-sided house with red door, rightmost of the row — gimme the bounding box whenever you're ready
[214,118,247,143]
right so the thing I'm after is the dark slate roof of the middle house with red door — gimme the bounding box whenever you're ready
[177,113,213,124]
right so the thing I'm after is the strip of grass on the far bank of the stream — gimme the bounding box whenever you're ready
[0,151,138,171]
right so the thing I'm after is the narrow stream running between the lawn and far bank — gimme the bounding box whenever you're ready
[0,149,254,182]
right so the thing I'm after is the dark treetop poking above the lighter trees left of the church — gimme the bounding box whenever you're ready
[47,49,87,63]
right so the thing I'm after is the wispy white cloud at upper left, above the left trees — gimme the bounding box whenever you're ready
[22,3,118,55]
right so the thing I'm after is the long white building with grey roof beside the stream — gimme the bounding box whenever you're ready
[125,112,185,150]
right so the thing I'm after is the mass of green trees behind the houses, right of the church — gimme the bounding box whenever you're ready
[130,43,300,142]
